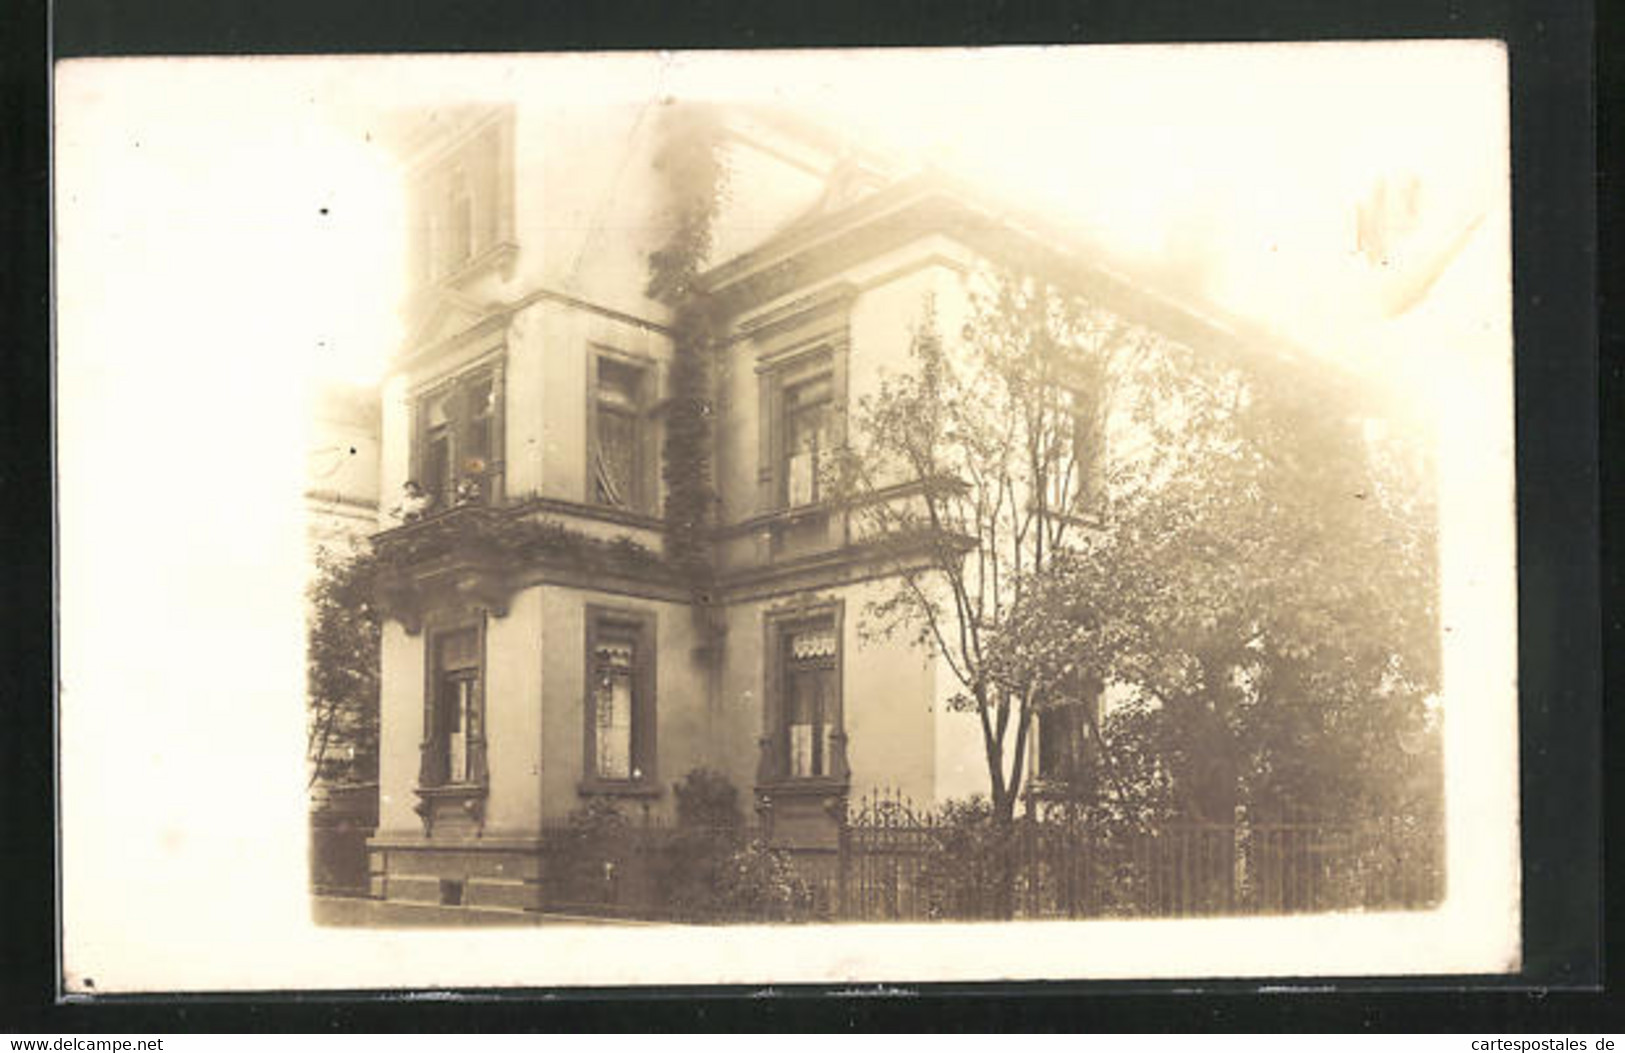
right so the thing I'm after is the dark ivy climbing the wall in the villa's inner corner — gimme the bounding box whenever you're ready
[647,101,728,605]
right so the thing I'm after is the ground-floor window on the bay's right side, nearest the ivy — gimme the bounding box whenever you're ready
[583,608,657,791]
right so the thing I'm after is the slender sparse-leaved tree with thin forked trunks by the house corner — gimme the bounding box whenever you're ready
[832,275,1178,826]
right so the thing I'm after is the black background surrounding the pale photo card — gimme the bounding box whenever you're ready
[0,0,1605,1037]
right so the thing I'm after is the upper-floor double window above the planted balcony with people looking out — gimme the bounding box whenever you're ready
[413,369,502,512]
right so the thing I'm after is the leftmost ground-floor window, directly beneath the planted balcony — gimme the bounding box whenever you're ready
[419,627,484,787]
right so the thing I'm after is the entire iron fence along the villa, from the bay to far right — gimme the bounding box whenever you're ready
[526,795,1445,921]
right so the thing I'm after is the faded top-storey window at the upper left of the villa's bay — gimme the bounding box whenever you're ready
[410,119,514,283]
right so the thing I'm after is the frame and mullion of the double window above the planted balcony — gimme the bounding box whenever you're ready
[410,358,507,515]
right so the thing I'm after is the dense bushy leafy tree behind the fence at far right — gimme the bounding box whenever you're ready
[995,349,1441,832]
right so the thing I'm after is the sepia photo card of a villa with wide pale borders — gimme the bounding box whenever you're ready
[59,42,1518,990]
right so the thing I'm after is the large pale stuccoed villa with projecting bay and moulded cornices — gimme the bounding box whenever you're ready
[371,100,1274,908]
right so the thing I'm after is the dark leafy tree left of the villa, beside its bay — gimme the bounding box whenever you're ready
[306,549,380,785]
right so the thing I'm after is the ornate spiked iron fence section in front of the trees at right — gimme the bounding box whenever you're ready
[840,795,1445,920]
